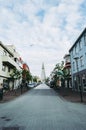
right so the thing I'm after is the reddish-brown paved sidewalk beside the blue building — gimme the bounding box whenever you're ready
[55,88,86,104]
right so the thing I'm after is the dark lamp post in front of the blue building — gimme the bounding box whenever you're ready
[74,57,83,102]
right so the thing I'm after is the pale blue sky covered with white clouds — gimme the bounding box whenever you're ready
[0,0,86,76]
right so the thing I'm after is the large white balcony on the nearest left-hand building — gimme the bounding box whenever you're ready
[2,56,18,68]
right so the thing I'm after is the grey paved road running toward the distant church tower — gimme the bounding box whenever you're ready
[0,84,86,130]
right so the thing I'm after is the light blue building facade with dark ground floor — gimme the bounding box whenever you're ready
[69,28,86,92]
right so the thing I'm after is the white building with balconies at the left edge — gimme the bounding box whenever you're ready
[0,42,22,88]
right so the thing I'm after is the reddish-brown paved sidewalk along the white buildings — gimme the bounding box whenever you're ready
[0,88,29,103]
